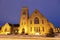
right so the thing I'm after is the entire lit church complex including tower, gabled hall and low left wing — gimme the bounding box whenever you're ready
[0,7,55,35]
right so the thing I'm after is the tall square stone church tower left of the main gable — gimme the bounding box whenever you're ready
[19,7,28,34]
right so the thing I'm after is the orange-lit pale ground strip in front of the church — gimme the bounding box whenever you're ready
[0,34,60,40]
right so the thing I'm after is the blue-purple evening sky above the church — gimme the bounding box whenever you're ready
[0,0,60,26]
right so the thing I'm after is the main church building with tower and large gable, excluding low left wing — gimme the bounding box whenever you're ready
[18,7,55,35]
